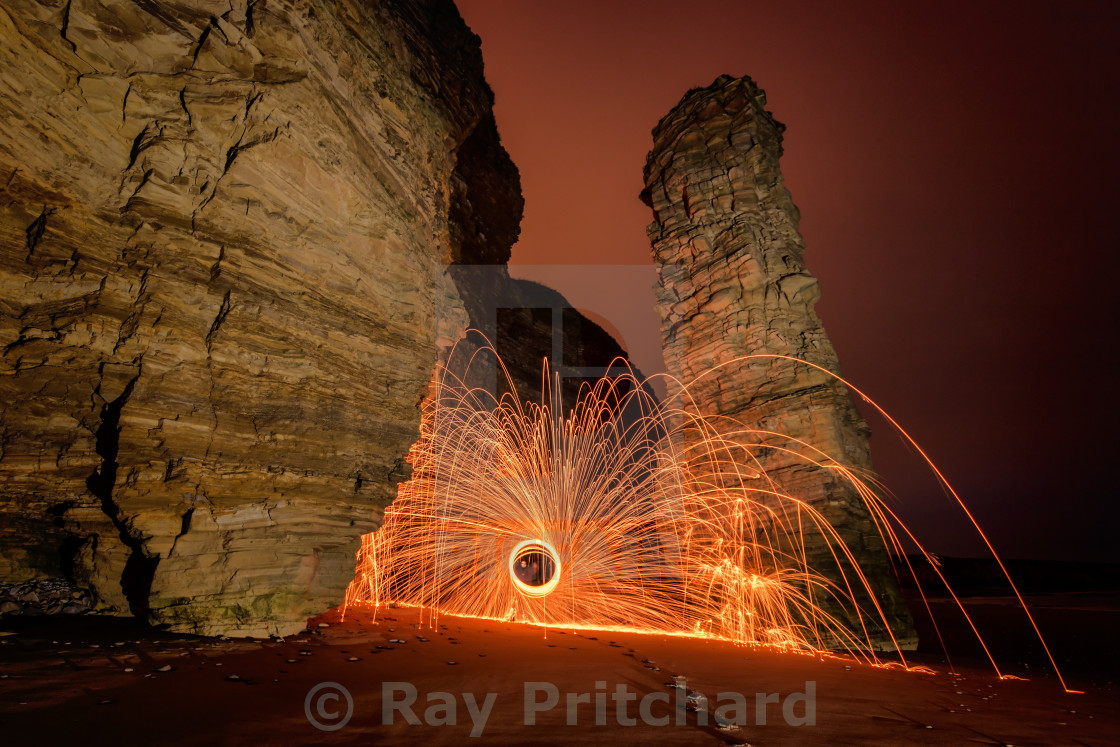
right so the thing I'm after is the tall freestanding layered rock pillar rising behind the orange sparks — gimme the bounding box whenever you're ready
[643,76,912,643]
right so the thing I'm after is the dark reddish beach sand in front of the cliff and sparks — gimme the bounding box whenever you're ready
[0,595,1120,747]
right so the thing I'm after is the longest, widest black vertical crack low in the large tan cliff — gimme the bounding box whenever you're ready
[85,371,159,619]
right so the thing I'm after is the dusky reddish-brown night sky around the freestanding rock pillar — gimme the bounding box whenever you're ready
[457,0,1120,561]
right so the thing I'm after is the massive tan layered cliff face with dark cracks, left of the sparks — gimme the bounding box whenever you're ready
[0,0,508,635]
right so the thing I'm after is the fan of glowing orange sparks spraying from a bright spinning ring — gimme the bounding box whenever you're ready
[346,344,1064,684]
